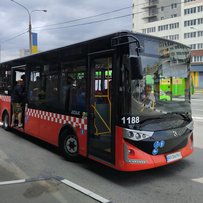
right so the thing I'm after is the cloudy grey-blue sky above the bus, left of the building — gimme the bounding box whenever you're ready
[0,0,132,62]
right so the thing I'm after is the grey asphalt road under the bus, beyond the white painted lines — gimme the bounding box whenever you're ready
[0,94,203,203]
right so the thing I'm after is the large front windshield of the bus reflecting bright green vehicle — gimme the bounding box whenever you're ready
[121,38,191,130]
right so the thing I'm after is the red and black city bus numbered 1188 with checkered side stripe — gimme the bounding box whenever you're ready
[0,31,193,171]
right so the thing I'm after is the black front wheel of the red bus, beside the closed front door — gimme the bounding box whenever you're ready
[60,129,79,161]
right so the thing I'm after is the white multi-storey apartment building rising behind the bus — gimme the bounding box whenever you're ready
[132,0,203,88]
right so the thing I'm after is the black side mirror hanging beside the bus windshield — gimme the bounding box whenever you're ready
[130,56,143,79]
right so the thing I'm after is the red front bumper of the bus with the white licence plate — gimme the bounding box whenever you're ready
[115,127,193,171]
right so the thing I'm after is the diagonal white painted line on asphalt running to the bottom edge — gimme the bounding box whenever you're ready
[61,179,110,203]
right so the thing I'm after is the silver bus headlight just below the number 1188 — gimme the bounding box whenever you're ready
[123,128,154,141]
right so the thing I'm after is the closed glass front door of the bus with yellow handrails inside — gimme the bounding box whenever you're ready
[88,55,114,163]
